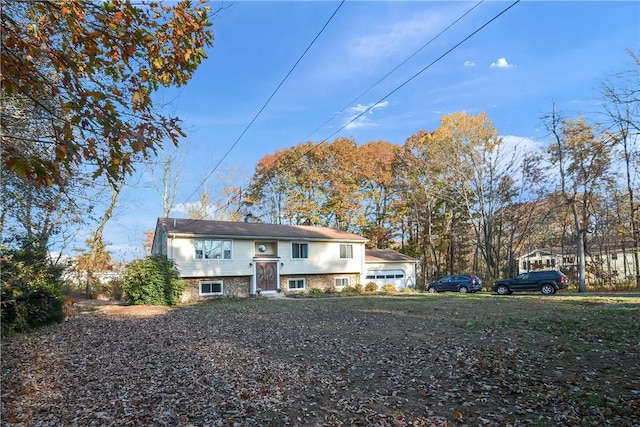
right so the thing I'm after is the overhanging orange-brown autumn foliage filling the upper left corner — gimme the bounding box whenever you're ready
[0,0,213,186]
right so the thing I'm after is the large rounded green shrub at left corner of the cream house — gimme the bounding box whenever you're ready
[122,255,184,305]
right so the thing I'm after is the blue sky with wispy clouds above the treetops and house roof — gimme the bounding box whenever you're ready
[86,1,640,259]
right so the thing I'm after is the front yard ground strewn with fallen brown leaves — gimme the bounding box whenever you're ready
[1,295,640,426]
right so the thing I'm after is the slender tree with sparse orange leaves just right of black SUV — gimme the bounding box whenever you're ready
[545,110,611,292]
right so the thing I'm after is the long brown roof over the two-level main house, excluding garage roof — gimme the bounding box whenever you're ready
[158,218,368,242]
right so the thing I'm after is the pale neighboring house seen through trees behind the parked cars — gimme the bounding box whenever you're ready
[518,247,635,281]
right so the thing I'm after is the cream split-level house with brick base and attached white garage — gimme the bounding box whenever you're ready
[151,218,415,300]
